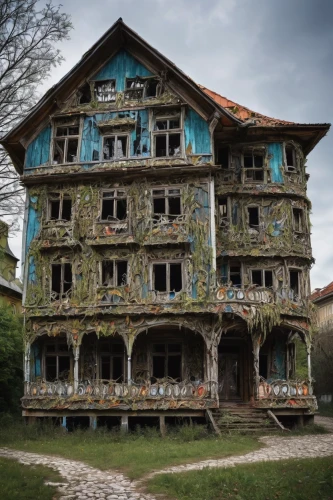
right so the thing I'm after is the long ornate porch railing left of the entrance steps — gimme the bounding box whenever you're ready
[25,379,216,399]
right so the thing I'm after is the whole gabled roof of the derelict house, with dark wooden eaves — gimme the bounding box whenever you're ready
[0,18,329,173]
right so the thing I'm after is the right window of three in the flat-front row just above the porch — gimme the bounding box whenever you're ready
[152,262,183,293]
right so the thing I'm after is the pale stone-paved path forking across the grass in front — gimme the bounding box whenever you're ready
[0,417,333,500]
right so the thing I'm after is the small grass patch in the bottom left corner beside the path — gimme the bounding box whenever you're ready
[0,458,63,500]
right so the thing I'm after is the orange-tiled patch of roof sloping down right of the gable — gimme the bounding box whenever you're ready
[199,85,296,127]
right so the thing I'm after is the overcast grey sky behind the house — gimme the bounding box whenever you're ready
[11,0,333,289]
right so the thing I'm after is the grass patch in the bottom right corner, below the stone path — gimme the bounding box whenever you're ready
[148,457,333,500]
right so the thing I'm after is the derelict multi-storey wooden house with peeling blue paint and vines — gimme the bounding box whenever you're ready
[2,19,329,428]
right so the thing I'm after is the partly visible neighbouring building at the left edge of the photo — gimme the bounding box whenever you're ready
[0,220,22,313]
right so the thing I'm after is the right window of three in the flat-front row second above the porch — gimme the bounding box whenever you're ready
[152,188,182,221]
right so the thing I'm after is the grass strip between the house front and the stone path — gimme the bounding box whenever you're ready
[0,421,261,479]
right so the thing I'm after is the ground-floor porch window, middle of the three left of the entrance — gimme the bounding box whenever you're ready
[99,339,125,382]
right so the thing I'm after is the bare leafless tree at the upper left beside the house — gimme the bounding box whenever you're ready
[0,0,73,230]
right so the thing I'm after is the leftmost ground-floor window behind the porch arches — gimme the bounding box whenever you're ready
[44,339,71,382]
